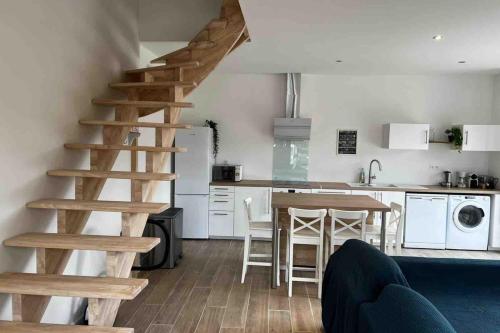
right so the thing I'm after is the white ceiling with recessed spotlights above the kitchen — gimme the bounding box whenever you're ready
[216,0,500,74]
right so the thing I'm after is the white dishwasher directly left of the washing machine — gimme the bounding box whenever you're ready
[404,193,448,249]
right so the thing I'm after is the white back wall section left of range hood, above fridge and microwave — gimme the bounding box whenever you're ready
[182,74,285,179]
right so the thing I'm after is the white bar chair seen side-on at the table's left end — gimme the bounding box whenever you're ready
[241,198,281,286]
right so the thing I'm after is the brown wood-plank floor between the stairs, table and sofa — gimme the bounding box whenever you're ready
[116,240,500,333]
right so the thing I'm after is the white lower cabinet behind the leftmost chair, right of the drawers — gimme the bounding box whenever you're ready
[234,186,272,237]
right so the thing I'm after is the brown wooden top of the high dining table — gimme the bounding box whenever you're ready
[271,192,391,212]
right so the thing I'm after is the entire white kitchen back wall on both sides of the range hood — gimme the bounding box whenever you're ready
[163,74,492,184]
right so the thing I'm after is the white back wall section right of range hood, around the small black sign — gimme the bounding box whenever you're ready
[301,75,493,184]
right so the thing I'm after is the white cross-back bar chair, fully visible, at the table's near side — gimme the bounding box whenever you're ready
[286,207,326,298]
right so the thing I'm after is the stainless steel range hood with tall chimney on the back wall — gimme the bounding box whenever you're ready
[274,73,311,140]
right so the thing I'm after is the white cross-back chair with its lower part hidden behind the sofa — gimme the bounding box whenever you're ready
[325,209,368,262]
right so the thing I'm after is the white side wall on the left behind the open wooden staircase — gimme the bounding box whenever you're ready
[0,0,139,323]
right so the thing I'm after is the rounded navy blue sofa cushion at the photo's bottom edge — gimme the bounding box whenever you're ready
[358,284,456,333]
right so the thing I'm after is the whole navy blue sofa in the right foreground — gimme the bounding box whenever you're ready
[322,240,500,333]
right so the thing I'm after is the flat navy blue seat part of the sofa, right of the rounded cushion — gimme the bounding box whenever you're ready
[395,257,500,333]
